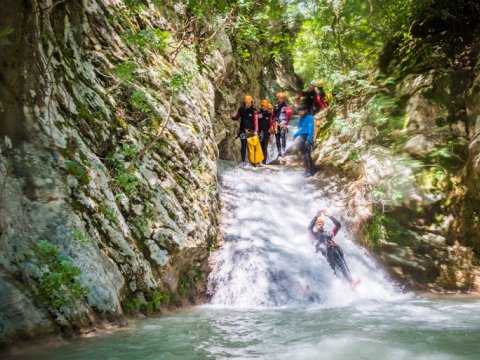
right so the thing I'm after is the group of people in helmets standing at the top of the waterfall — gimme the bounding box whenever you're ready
[232,81,327,176]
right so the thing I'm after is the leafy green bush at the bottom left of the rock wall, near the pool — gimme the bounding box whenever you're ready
[32,240,89,311]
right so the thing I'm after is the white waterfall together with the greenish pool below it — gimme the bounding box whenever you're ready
[6,156,480,360]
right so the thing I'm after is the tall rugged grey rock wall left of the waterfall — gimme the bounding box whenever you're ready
[0,0,296,344]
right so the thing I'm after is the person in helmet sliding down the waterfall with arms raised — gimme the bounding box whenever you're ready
[308,210,360,287]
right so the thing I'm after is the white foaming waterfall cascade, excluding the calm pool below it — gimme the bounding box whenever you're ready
[209,162,405,308]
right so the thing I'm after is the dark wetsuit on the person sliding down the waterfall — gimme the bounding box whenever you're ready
[308,216,352,282]
